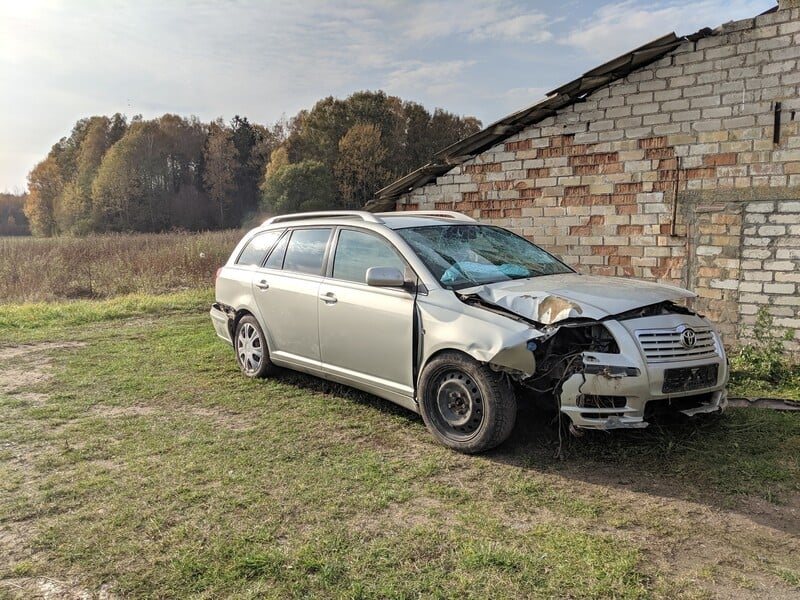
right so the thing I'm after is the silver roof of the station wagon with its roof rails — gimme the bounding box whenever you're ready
[262,210,477,229]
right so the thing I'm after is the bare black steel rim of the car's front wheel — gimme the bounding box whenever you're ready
[435,370,484,438]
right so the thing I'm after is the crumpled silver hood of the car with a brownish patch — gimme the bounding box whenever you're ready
[458,273,695,325]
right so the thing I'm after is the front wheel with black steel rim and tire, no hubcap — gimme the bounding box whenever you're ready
[419,352,517,454]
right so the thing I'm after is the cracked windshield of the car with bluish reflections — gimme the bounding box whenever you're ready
[397,225,573,290]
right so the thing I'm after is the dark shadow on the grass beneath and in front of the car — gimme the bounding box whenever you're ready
[266,371,800,535]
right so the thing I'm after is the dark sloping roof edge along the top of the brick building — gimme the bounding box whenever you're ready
[367,27,714,210]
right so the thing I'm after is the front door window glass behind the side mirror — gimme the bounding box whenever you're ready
[333,229,406,283]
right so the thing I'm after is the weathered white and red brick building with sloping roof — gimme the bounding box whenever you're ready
[376,0,800,350]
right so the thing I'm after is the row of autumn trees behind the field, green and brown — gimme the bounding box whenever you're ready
[21,91,481,236]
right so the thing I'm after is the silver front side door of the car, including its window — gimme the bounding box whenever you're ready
[319,228,414,398]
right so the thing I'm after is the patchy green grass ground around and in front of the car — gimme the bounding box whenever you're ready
[0,289,800,598]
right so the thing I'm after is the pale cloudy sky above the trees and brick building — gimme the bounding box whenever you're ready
[0,0,776,192]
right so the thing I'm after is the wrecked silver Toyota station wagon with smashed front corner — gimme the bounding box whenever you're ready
[211,211,728,453]
